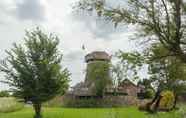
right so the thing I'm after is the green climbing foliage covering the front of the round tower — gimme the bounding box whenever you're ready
[86,61,112,96]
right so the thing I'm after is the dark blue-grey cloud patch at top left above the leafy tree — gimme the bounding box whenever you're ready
[16,0,45,21]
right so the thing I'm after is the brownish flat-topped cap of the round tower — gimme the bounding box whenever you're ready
[85,51,111,62]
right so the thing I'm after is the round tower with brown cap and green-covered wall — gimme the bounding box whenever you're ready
[85,51,111,86]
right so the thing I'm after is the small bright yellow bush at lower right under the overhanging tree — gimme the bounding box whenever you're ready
[159,91,175,110]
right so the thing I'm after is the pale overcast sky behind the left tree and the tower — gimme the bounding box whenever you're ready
[0,0,142,90]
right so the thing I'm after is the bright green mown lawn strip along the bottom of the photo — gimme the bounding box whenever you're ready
[0,107,186,118]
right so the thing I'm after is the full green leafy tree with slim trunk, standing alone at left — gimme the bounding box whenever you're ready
[0,28,69,118]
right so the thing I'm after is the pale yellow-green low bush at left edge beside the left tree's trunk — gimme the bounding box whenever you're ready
[0,97,24,113]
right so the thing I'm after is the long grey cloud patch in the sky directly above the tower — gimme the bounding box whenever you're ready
[72,11,127,40]
